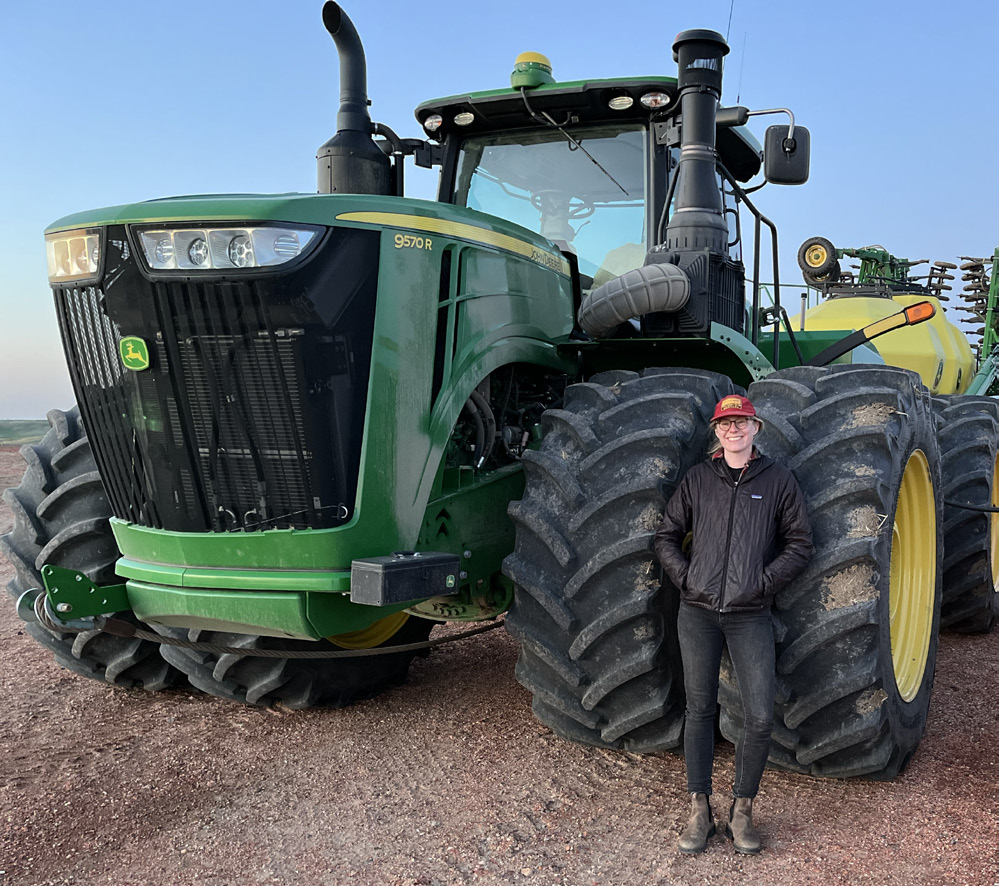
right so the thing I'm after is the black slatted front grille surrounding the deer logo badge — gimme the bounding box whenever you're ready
[55,229,378,531]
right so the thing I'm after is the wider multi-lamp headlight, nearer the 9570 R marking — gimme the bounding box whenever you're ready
[139,226,317,271]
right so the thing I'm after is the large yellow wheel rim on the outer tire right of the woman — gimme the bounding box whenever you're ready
[888,449,937,702]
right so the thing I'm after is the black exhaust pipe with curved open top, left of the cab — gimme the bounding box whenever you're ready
[316,0,393,194]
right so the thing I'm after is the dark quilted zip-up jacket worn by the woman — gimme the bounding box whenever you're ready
[655,451,812,612]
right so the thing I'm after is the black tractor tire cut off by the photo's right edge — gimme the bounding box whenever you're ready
[933,394,999,633]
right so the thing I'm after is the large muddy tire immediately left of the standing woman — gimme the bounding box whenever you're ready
[503,369,736,752]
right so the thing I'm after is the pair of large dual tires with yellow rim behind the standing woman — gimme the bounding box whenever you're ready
[505,366,943,778]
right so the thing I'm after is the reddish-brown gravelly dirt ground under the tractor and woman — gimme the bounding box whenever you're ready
[0,447,999,886]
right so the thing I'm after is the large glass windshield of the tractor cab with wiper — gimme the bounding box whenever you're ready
[454,126,648,285]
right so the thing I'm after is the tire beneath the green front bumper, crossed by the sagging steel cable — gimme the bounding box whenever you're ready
[156,616,434,710]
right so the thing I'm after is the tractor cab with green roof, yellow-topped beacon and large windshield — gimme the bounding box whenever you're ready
[416,60,762,300]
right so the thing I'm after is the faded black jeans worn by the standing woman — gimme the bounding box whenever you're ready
[677,603,775,797]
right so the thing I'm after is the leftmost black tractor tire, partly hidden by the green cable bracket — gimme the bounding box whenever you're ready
[0,407,180,691]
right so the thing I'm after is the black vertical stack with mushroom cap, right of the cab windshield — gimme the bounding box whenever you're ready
[664,30,728,255]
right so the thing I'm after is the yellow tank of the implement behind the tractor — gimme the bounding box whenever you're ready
[792,294,975,394]
